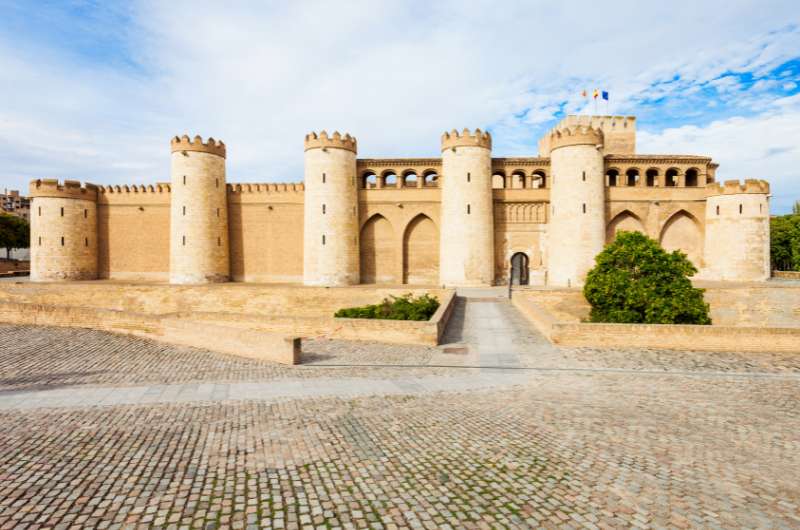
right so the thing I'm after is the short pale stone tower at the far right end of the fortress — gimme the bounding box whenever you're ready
[702,179,770,281]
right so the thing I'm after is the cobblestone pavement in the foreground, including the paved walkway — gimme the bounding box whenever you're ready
[0,292,800,528]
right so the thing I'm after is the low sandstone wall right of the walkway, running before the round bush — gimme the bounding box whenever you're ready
[512,291,800,353]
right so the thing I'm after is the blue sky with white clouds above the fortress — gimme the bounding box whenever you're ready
[0,0,800,213]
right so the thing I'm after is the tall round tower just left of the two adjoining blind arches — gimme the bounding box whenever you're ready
[303,131,359,286]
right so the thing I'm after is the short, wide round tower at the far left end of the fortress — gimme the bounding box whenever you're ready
[30,179,97,281]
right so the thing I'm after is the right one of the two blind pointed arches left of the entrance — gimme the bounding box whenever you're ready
[403,213,439,285]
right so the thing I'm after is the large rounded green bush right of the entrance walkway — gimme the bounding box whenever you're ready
[583,232,711,324]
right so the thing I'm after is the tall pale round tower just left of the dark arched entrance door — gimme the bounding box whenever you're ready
[439,129,494,287]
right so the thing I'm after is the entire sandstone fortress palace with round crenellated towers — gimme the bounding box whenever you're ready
[30,116,769,287]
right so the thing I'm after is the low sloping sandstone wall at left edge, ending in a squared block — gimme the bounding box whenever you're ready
[0,302,300,364]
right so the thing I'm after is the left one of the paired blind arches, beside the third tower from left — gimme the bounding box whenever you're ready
[360,213,397,283]
